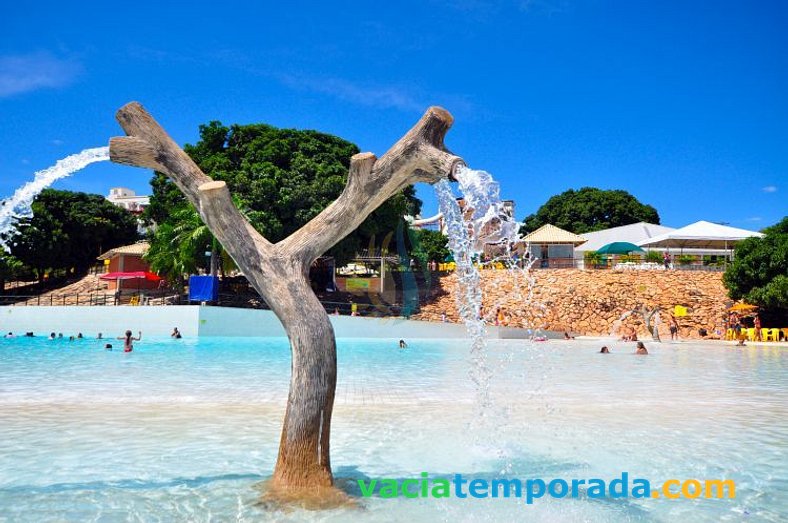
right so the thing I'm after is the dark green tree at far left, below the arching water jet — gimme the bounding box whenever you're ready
[8,189,138,280]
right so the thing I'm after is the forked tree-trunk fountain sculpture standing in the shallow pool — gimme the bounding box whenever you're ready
[110,102,462,500]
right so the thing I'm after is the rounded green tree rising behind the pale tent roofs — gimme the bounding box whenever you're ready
[520,187,659,234]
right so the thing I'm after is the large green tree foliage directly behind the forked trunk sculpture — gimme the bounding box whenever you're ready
[146,121,421,272]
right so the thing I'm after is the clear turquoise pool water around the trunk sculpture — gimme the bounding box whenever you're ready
[0,338,788,522]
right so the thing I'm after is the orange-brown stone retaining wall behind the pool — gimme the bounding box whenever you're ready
[416,269,731,339]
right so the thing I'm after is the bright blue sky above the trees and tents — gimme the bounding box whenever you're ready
[0,0,788,229]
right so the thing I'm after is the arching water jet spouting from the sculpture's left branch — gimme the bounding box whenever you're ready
[0,147,109,249]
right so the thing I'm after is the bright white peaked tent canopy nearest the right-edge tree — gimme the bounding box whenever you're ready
[637,220,763,250]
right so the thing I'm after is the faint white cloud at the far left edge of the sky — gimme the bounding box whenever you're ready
[0,52,82,98]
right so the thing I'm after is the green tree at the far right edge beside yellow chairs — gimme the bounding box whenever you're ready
[722,216,788,317]
